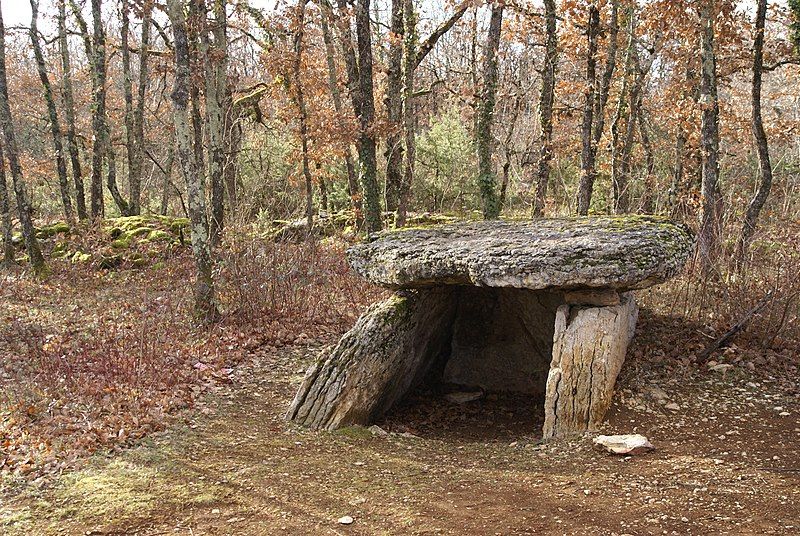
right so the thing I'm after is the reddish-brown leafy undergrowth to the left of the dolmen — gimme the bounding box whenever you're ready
[0,233,380,476]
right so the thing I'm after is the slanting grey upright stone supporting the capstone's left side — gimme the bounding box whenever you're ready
[286,288,457,430]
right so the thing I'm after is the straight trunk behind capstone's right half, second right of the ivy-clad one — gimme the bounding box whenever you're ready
[577,4,600,216]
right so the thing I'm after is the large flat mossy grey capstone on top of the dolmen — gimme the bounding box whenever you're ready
[348,216,694,291]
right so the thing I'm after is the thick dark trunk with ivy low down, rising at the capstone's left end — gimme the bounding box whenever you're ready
[356,0,383,233]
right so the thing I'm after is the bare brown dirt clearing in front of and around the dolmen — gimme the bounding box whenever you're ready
[0,311,800,535]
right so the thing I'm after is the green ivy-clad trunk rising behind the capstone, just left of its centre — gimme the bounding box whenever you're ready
[475,2,505,220]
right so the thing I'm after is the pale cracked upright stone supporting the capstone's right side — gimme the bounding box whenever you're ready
[543,293,638,439]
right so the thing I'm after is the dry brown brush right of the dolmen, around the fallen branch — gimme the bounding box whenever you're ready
[641,222,800,368]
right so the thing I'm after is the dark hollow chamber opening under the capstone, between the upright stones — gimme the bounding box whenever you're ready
[377,286,564,442]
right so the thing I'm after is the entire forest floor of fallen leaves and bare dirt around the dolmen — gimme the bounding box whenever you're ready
[0,231,800,535]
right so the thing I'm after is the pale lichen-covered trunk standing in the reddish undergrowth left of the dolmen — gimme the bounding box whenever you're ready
[167,0,219,323]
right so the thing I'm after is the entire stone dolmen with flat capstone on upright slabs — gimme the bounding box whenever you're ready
[287,216,694,439]
